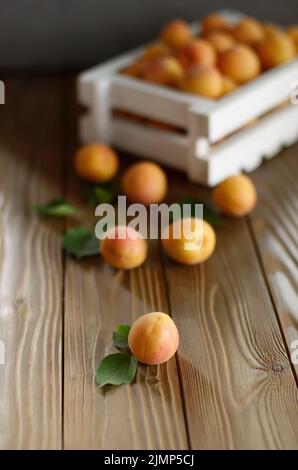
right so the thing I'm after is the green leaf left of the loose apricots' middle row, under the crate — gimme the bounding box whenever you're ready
[63,227,100,258]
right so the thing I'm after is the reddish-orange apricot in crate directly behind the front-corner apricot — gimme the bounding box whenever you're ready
[177,39,216,70]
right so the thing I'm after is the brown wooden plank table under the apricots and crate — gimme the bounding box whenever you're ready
[0,77,298,449]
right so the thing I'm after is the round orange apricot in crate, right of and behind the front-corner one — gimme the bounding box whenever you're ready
[218,44,261,83]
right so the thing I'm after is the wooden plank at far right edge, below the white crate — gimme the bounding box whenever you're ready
[251,145,298,377]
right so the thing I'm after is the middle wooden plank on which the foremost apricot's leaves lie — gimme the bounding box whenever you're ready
[64,79,188,449]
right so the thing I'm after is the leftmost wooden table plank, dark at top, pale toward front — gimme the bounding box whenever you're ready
[0,79,62,449]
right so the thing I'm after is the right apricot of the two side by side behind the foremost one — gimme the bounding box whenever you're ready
[161,217,216,265]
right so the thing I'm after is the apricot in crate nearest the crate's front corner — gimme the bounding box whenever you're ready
[181,65,223,98]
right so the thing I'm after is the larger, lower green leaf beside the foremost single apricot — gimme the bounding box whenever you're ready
[96,353,138,387]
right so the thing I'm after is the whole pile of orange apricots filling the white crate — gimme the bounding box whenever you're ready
[123,13,298,99]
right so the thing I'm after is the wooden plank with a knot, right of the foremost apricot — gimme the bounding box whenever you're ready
[164,171,298,449]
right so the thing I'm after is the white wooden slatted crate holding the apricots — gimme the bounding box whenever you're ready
[78,11,298,186]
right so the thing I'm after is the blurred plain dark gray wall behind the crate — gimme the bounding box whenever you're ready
[0,0,298,71]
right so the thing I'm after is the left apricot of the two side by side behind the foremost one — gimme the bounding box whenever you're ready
[101,225,148,269]
